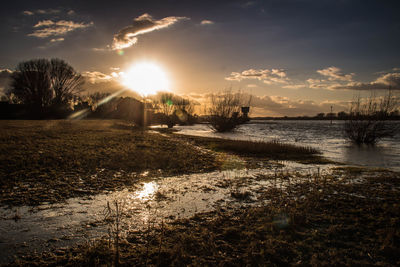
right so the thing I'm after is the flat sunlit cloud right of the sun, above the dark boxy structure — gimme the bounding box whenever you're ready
[225,69,289,84]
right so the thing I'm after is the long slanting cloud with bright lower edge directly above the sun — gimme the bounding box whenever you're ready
[112,13,189,50]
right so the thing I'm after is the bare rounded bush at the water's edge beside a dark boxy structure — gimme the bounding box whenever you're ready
[207,90,251,132]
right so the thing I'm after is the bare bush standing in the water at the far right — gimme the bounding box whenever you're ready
[344,90,399,145]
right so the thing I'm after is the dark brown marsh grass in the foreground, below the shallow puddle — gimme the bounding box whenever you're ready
[10,172,400,266]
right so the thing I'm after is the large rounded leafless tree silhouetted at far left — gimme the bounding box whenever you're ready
[8,59,83,118]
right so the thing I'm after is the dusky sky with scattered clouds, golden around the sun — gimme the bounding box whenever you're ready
[0,0,400,116]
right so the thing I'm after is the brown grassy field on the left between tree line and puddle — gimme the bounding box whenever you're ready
[0,120,220,205]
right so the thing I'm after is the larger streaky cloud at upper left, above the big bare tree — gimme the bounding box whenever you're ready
[28,20,94,38]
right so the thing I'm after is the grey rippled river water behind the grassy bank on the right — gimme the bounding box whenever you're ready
[176,120,400,171]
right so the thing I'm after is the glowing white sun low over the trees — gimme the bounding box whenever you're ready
[122,62,170,96]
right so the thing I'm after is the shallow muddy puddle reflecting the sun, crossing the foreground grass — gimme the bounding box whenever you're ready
[0,162,340,263]
